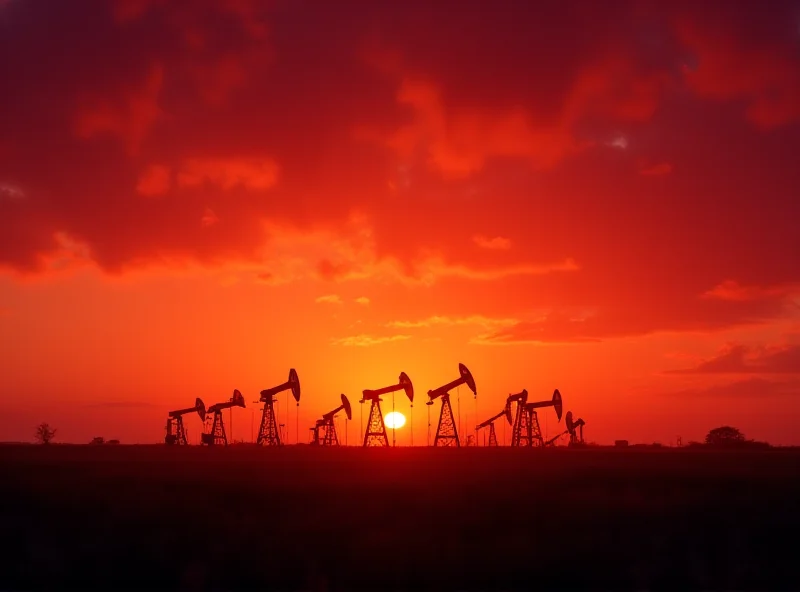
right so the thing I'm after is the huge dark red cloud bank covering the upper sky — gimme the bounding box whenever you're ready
[0,0,800,342]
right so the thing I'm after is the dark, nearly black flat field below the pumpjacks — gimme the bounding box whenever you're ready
[0,445,800,590]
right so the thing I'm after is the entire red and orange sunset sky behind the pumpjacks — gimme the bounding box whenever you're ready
[0,0,800,444]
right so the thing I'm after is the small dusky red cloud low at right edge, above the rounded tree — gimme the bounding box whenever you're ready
[667,344,800,374]
